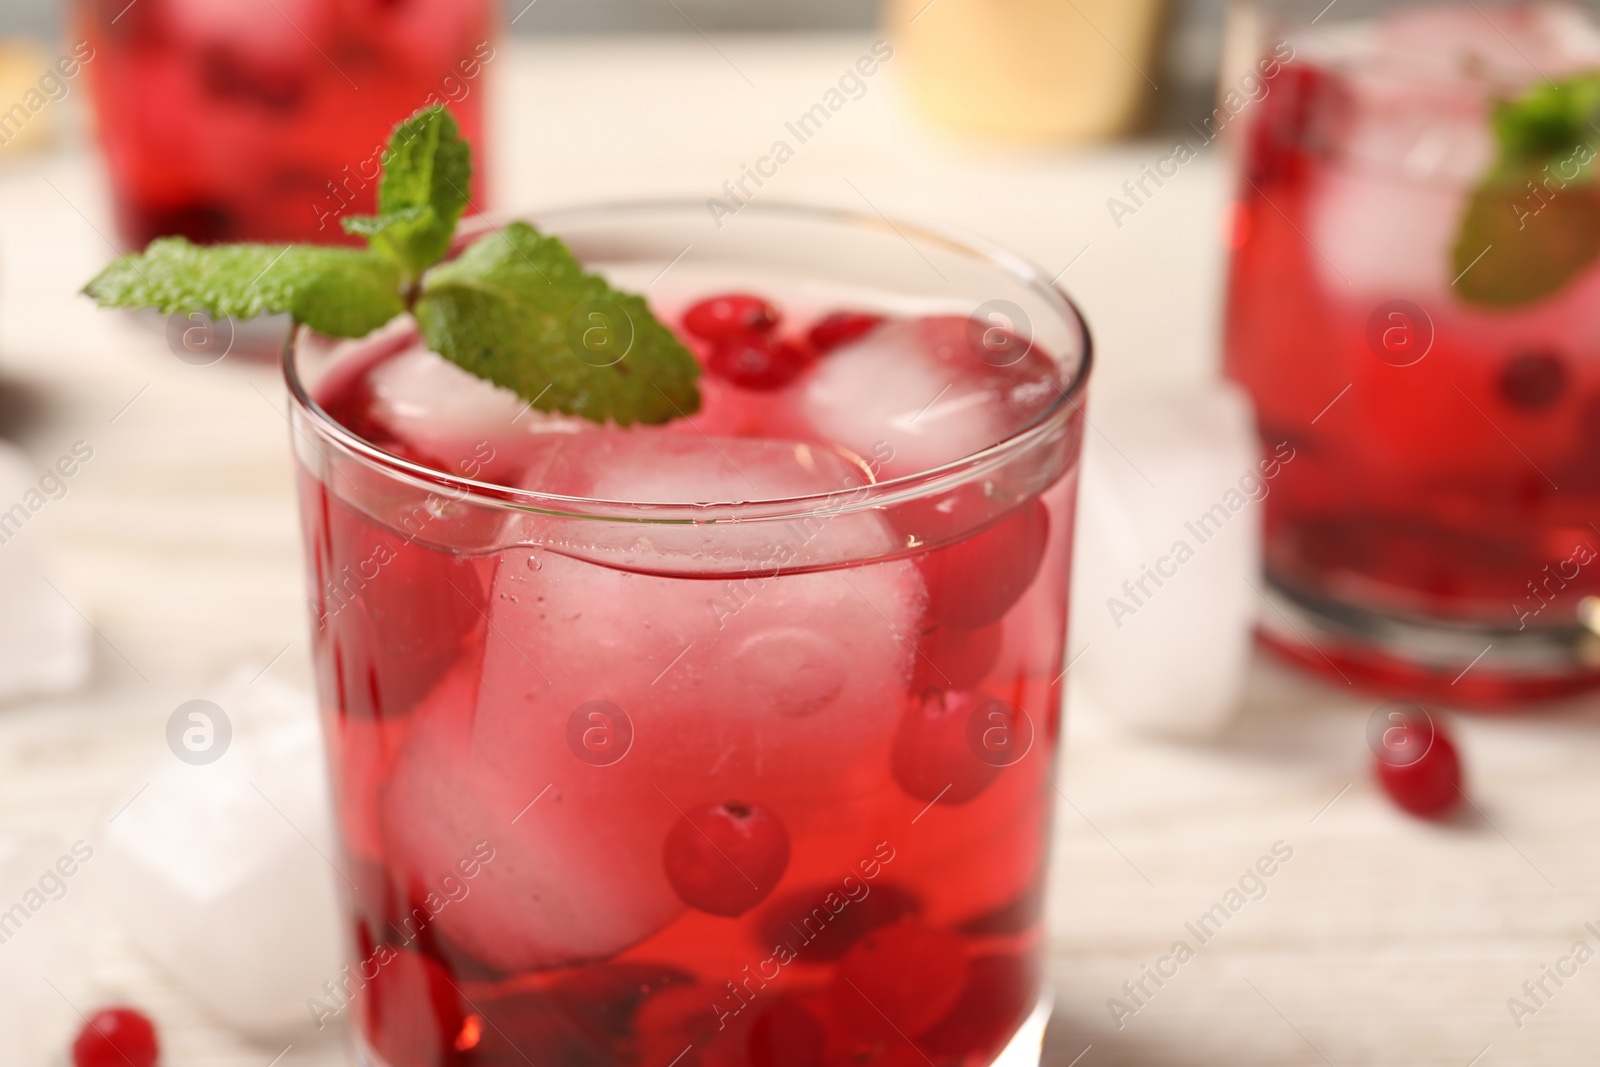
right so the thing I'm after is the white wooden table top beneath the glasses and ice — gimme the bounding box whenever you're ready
[0,37,1600,1067]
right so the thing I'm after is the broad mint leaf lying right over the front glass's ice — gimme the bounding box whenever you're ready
[413,222,699,426]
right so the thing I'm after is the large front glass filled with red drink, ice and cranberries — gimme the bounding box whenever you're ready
[285,203,1090,1067]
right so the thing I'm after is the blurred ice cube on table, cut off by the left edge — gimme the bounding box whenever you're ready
[0,442,90,702]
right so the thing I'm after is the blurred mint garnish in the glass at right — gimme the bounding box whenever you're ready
[1451,72,1600,309]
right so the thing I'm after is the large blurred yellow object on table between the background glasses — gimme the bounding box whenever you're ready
[886,0,1166,141]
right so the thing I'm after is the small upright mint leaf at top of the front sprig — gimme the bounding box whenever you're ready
[360,106,472,278]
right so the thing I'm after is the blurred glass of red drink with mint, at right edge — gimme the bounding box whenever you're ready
[1227,0,1600,704]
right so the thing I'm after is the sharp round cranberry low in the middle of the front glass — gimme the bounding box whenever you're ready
[662,801,789,917]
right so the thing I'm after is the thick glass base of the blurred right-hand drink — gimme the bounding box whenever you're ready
[1258,577,1600,710]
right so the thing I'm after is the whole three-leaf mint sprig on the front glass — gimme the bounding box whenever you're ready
[85,107,699,426]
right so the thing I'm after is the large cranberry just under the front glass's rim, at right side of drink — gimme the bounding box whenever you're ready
[918,499,1050,630]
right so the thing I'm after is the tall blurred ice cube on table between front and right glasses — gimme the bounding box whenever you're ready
[1067,384,1267,736]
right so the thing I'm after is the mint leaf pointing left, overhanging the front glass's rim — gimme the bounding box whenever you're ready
[83,237,405,338]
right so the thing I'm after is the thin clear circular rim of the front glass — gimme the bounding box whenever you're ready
[282,198,1094,525]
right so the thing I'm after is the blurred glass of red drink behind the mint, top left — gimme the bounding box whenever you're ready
[75,0,494,248]
